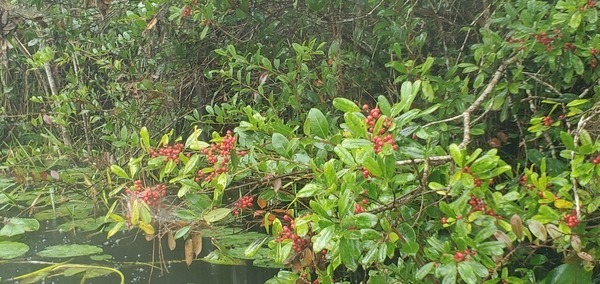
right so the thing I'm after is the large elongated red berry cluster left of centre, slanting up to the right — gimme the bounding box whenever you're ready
[194,130,237,182]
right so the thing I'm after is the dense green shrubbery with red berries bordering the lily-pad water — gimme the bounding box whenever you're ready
[0,0,600,283]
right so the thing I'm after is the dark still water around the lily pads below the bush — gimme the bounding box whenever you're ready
[0,221,277,284]
